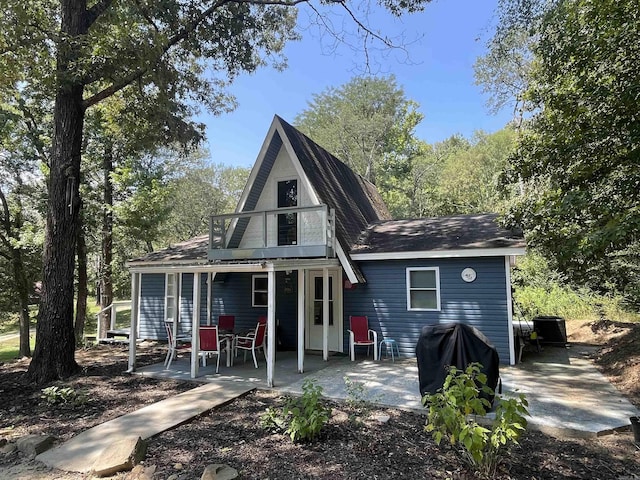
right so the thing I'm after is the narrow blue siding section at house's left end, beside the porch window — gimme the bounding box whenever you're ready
[139,273,167,340]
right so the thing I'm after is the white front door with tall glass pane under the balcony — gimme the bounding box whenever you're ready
[306,270,342,352]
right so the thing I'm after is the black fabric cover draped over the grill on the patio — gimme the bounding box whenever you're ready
[416,323,500,402]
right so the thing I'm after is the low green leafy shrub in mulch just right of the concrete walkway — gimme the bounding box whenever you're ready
[260,380,331,442]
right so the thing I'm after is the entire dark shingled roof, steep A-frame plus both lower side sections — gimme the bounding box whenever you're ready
[126,115,525,266]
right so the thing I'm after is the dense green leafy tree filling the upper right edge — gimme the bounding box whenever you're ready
[500,0,640,303]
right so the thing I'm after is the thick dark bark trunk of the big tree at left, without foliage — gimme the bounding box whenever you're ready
[27,0,87,383]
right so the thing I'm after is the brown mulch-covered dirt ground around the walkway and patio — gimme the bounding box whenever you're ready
[0,320,640,480]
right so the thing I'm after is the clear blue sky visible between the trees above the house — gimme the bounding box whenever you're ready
[200,0,510,167]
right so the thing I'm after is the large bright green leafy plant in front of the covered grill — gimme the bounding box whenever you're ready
[422,363,529,476]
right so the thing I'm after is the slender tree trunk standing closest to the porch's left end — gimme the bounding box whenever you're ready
[99,144,115,338]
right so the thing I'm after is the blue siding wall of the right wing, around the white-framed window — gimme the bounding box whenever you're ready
[344,257,509,363]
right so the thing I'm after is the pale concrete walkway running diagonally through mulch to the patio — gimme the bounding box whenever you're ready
[36,383,254,473]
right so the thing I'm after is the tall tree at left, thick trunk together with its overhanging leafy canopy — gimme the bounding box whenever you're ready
[0,0,436,382]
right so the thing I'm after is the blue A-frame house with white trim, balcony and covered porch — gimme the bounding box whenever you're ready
[128,116,525,384]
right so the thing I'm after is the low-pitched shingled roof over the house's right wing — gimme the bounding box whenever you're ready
[350,213,525,254]
